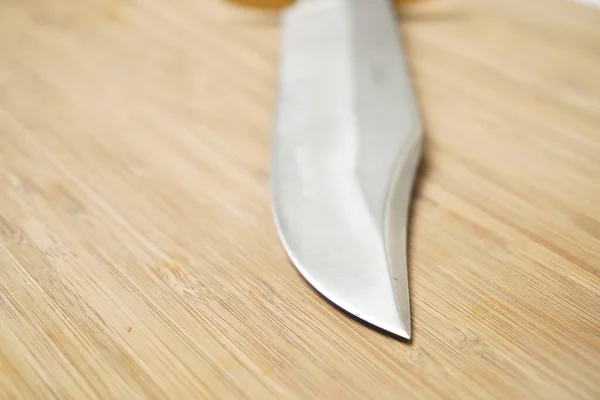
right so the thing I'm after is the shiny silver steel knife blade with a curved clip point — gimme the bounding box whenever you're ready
[271,0,422,338]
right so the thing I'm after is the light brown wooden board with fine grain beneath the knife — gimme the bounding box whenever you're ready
[0,0,600,400]
